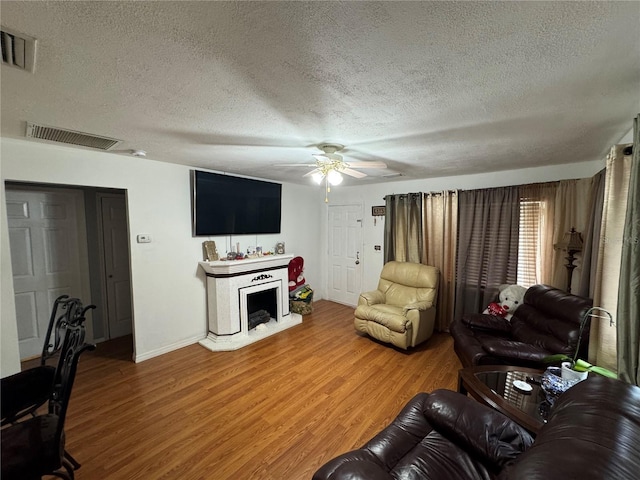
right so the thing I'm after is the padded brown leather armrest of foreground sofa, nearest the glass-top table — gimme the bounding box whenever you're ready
[424,390,533,472]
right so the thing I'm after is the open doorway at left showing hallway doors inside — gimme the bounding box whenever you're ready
[6,182,133,360]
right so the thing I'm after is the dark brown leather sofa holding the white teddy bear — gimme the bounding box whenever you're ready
[449,285,592,368]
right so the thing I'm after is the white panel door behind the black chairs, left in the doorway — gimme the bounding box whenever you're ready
[6,187,82,359]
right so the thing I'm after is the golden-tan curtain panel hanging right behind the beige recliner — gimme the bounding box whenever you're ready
[422,191,458,332]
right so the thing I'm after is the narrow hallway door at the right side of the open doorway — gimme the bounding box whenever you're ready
[100,195,133,338]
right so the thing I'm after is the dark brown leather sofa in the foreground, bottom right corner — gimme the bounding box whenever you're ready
[313,377,640,480]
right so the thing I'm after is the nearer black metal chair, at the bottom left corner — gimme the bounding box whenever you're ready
[0,322,95,480]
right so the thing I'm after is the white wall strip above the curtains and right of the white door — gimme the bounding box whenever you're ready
[329,159,605,291]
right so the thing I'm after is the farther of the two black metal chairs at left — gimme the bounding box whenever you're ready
[0,295,96,425]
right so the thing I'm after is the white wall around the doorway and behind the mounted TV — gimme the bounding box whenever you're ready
[0,138,324,376]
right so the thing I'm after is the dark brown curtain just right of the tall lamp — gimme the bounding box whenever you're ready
[576,169,606,298]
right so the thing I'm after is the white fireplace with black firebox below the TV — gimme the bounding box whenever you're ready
[199,255,302,351]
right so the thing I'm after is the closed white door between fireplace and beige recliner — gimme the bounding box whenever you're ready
[328,205,362,307]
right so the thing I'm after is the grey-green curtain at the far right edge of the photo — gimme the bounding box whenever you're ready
[616,116,640,385]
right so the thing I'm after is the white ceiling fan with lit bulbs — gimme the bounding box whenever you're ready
[278,143,387,202]
